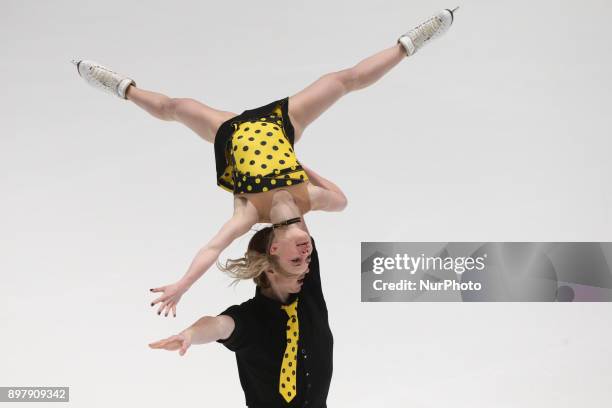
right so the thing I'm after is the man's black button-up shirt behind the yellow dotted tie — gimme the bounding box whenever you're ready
[218,237,334,408]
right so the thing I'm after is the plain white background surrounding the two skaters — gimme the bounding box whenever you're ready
[0,0,612,408]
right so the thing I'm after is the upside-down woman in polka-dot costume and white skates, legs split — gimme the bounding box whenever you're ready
[72,8,456,317]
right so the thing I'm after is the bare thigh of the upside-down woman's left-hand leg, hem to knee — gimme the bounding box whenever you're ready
[171,98,237,143]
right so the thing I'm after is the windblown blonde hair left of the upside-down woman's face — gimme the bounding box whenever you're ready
[217,227,290,288]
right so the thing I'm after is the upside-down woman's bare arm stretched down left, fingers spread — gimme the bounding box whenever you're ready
[151,198,258,316]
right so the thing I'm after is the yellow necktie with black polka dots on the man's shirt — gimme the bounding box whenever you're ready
[278,299,300,402]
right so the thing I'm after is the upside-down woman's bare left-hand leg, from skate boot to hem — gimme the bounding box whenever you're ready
[126,85,237,143]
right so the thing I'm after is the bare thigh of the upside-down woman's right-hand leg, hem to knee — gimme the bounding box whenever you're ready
[289,69,352,142]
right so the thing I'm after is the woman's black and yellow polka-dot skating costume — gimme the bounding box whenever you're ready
[214,97,308,194]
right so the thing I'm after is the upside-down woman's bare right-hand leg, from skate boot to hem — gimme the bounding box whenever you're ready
[289,44,406,142]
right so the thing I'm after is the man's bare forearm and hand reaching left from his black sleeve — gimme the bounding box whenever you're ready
[149,315,234,356]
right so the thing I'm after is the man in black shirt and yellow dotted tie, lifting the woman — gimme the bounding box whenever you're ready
[149,231,333,408]
